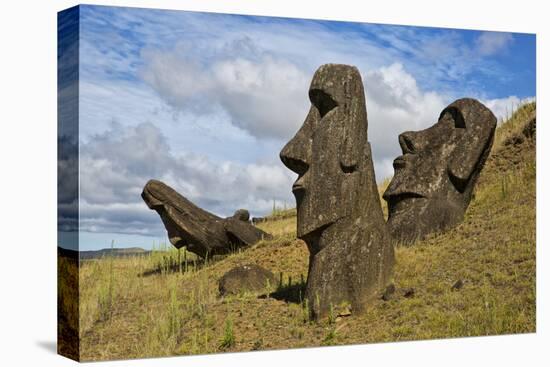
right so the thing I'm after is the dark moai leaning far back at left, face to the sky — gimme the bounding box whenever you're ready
[141,180,271,257]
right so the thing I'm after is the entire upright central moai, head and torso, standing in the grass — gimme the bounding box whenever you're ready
[280,64,394,318]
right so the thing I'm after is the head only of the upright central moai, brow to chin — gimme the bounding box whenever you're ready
[280,64,372,242]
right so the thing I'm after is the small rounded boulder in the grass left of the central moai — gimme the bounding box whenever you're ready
[218,264,275,295]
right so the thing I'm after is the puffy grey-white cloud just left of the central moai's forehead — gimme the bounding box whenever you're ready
[142,47,309,138]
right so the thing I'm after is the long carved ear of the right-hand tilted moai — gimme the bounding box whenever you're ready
[448,99,496,191]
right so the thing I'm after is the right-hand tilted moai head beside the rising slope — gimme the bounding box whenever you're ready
[384,98,496,244]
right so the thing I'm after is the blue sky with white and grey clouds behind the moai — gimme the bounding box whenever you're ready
[60,6,535,250]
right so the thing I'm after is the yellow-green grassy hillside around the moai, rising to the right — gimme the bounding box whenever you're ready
[75,104,536,360]
